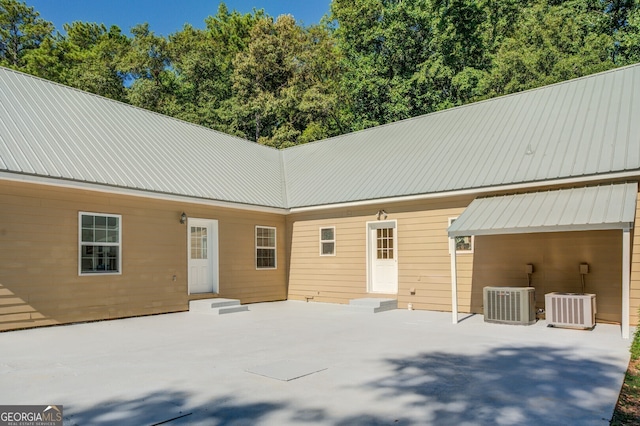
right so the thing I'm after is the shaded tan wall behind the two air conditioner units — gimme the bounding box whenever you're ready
[471,230,622,322]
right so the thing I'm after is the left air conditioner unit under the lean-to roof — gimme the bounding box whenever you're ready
[483,287,536,325]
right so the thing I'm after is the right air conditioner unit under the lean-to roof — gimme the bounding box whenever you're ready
[544,292,596,328]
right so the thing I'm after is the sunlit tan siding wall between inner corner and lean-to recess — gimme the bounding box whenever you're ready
[288,197,473,311]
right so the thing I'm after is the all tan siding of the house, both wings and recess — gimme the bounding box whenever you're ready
[0,181,640,330]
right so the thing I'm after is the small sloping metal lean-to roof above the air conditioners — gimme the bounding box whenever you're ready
[448,182,638,237]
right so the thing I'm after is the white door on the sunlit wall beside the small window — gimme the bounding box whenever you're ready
[368,221,398,294]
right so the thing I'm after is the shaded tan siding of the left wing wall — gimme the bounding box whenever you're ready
[0,181,286,330]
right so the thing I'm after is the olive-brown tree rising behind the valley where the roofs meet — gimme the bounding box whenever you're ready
[227,15,340,148]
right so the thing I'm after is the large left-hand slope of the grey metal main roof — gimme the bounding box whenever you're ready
[0,68,286,208]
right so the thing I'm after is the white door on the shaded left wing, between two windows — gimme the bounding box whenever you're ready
[187,219,218,294]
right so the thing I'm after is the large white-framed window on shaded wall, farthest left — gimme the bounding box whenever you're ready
[78,212,122,275]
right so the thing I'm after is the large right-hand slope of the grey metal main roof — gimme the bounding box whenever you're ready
[284,64,640,207]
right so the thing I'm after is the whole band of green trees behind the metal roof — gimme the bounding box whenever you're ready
[5,0,640,148]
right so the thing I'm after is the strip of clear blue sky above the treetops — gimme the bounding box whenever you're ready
[26,0,331,36]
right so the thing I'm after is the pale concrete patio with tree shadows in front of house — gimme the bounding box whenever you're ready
[0,301,630,425]
